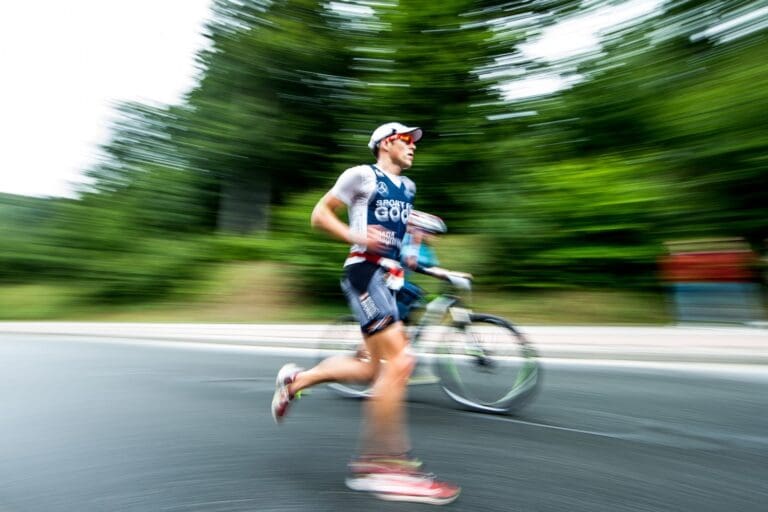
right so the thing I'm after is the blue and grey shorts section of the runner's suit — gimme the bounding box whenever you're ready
[341,261,400,336]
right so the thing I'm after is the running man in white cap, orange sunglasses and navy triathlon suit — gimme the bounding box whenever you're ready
[272,122,460,504]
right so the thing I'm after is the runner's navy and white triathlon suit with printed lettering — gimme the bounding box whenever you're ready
[331,165,416,335]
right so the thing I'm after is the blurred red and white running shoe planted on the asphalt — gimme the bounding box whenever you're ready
[346,472,461,505]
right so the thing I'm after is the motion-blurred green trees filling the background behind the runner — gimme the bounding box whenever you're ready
[0,0,768,301]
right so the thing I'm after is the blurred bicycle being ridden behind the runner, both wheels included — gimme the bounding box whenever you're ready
[319,212,541,414]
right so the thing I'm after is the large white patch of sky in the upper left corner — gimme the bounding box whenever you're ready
[0,0,210,196]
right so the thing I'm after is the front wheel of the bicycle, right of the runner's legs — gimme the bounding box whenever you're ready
[436,314,541,414]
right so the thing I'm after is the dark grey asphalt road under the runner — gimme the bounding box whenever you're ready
[0,335,768,512]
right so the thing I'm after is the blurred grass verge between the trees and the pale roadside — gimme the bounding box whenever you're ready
[0,262,671,325]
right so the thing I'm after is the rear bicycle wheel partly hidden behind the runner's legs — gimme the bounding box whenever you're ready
[317,315,371,398]
